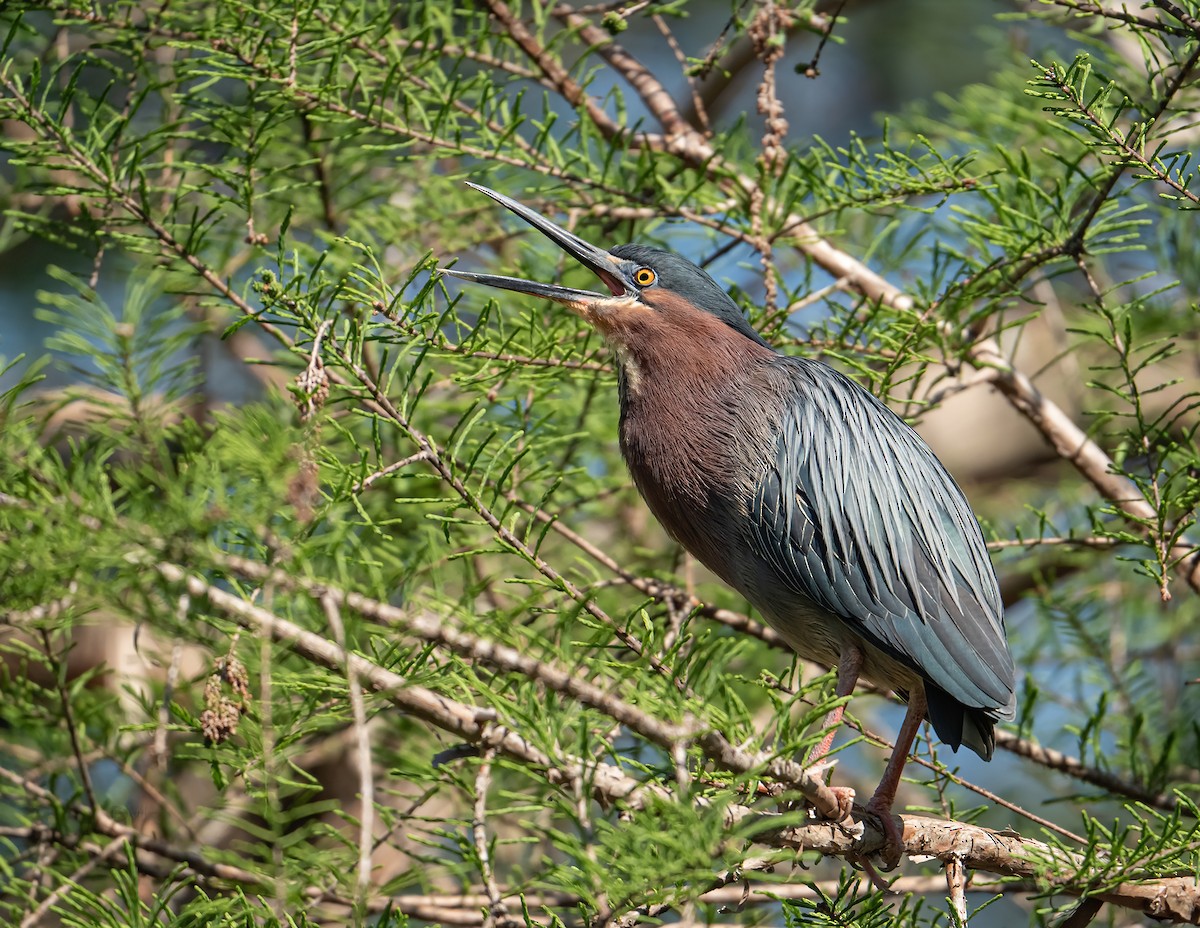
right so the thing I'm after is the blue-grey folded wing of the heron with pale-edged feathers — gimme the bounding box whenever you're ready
[752,358,1015,718]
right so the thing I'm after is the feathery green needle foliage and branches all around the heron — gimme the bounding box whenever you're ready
[0,0,1200,928]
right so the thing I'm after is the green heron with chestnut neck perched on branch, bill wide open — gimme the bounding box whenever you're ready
[445,184,1016,858]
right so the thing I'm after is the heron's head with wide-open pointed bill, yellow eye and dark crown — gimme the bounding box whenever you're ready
[443,184,766,345]
